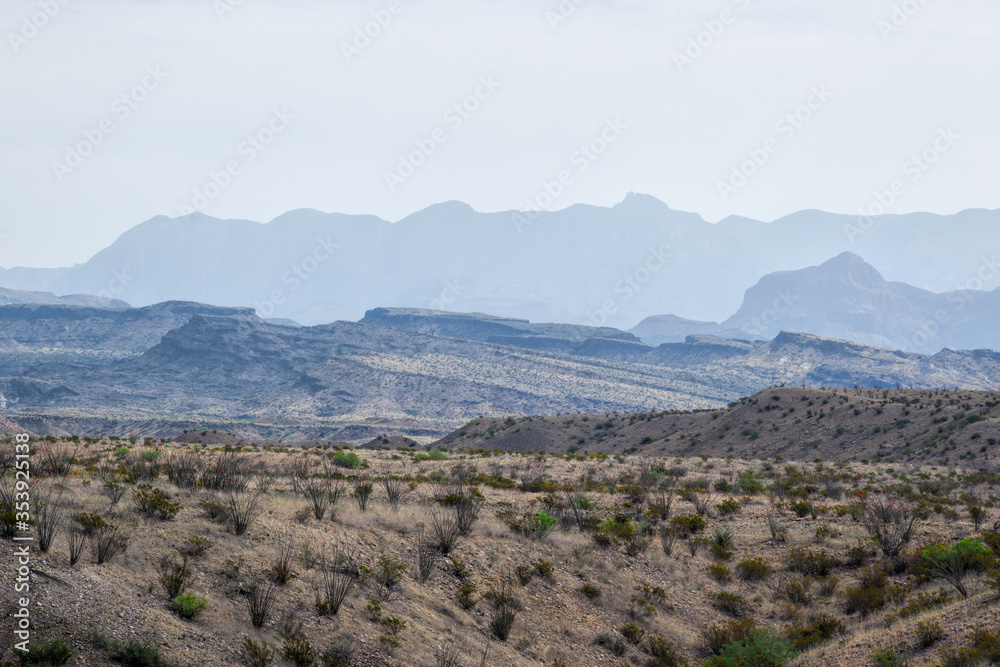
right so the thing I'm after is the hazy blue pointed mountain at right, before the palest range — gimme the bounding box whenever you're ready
[631,252,1000,353]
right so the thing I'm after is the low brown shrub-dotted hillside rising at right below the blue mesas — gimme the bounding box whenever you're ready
[434,387,1000,466]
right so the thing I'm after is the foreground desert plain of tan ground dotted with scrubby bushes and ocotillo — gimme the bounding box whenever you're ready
[0,408,1000,667]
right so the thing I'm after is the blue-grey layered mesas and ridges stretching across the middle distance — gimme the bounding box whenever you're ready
[0,302,1000,440]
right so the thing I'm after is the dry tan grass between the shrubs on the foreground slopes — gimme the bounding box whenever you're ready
[0,444,998,665]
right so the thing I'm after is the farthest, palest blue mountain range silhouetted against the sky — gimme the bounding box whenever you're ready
[0,194,1000,332]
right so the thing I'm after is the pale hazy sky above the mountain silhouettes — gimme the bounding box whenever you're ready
[0,0,1000,267]
